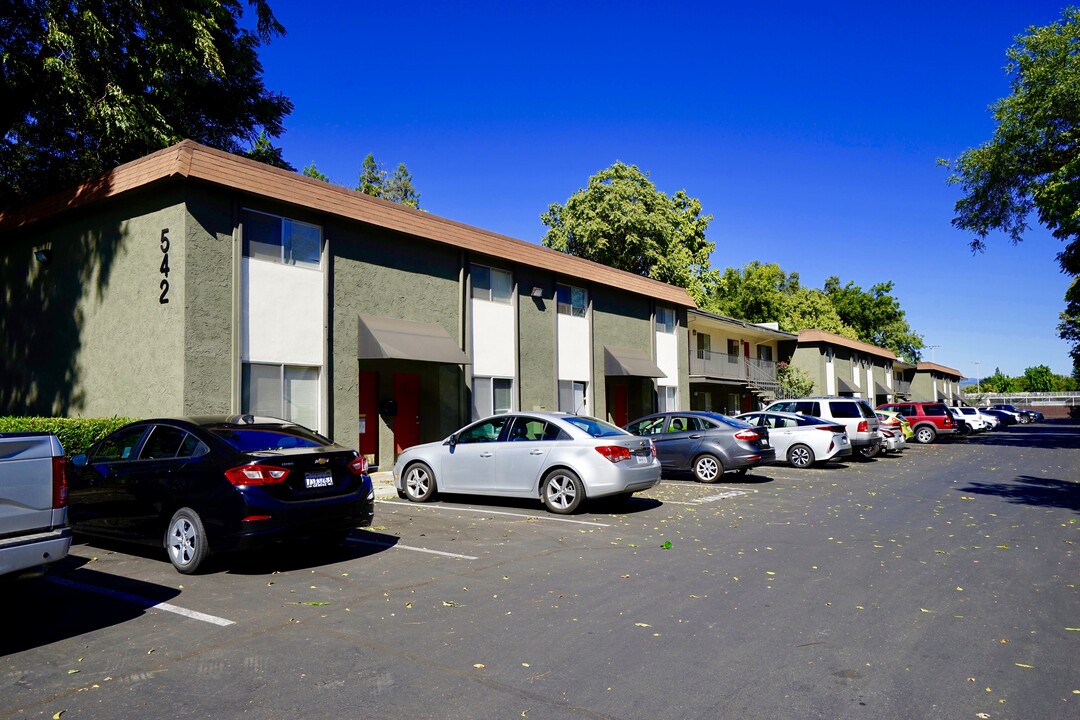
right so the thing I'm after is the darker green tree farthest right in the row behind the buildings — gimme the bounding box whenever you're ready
[825,275,923,363]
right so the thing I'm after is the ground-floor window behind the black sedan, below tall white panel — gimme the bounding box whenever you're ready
[241,363,319,430]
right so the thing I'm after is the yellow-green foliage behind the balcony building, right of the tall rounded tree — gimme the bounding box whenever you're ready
[703,260,859,340]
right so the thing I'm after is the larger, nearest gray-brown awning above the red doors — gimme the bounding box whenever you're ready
[356,315,471,365]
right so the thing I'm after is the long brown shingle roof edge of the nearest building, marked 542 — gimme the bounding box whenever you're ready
[0,140,697,308]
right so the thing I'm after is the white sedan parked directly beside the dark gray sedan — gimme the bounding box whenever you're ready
[735,410,851,467]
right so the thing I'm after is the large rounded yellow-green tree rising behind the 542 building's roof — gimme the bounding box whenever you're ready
[540,162,719,304]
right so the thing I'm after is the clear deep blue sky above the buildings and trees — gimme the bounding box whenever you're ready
[250,0,1071,377]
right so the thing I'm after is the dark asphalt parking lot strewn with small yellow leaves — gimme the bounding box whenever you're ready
[0,422,1080,719]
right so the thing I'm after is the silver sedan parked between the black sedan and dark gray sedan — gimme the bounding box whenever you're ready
[394,412,660,515]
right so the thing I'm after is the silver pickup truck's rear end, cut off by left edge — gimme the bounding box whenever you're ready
[0,433,71,575]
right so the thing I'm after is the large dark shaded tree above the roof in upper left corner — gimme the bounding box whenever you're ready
[0,0,293,207]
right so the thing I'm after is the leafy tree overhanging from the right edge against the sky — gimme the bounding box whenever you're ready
[942,8,1080,363]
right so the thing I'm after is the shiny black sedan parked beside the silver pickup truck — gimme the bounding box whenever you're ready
[68,416,375,574]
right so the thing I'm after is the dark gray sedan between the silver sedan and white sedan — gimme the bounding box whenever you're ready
[626,411,777,483]
